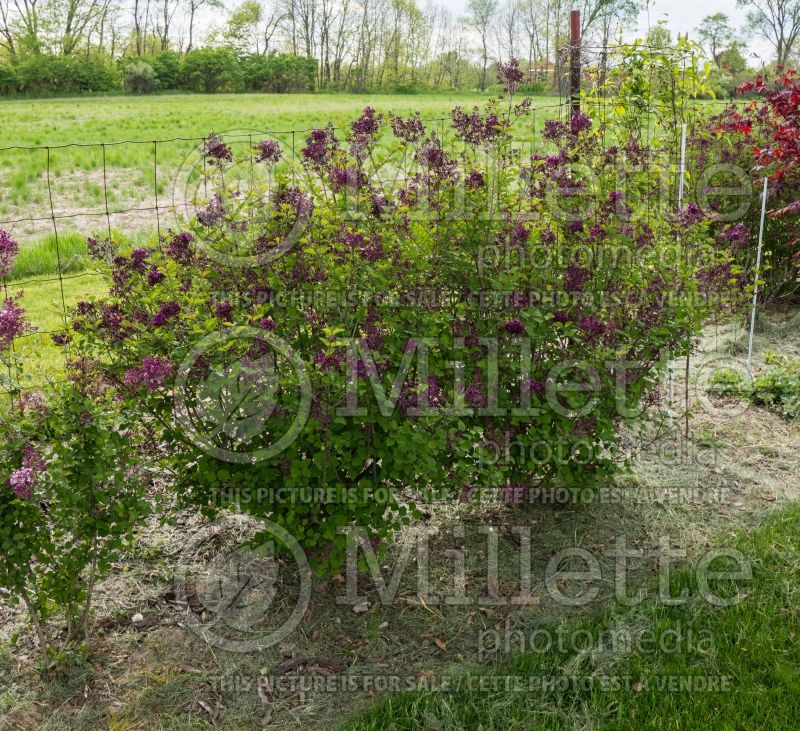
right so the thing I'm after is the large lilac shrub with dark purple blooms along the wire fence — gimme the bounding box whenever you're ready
[68,77,730,570]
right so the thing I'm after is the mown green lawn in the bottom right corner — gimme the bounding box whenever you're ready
[341,504,800,731]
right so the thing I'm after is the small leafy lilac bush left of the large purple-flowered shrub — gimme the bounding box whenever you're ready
[0,379,149,662]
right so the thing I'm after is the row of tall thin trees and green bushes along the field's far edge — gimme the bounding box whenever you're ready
[0,0,800,93]
